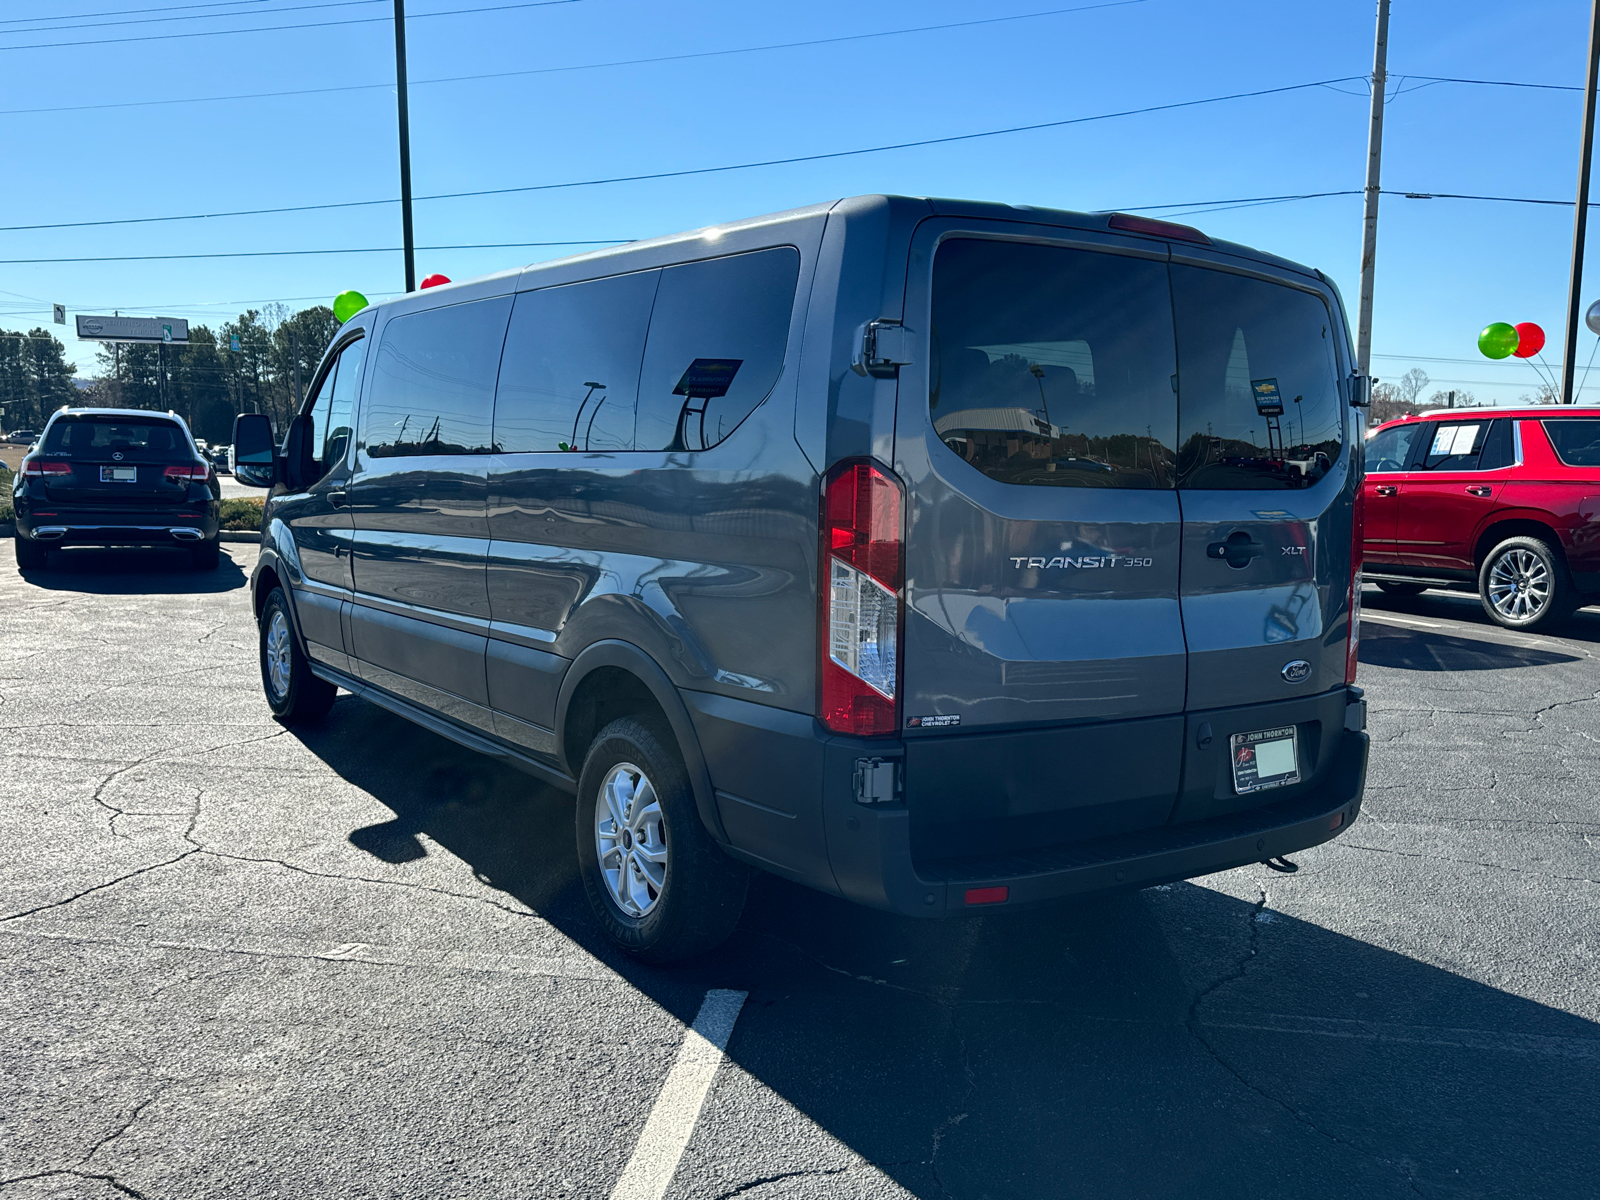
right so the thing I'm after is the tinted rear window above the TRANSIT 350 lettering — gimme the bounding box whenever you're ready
[928,238,1178,488]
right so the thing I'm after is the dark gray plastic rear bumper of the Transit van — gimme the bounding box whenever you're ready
[829,730,1370,917]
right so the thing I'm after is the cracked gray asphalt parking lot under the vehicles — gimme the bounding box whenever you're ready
[0,544,1600,1200]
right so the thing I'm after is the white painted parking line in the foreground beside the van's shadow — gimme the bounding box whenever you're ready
[611,989,749,1200]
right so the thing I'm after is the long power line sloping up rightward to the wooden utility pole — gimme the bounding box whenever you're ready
[0,77,1355,236]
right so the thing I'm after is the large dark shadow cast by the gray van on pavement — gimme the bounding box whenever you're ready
[296,696,1600,1200]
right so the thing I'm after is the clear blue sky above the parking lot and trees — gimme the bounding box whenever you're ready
[0,0,1600,400]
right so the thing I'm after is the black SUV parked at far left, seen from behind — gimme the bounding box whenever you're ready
[11,408,222,571]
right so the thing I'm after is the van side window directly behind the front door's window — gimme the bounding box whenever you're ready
[362,296,510,458]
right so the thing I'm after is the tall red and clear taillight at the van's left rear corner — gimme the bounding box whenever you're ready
[818,461,904,738]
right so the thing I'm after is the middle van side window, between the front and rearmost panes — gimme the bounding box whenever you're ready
[494,270,661,454]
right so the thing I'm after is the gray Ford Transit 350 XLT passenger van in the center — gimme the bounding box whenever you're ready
[234,197,1370,962]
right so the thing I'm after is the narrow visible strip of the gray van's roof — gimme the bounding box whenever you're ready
[373,195,1333,307]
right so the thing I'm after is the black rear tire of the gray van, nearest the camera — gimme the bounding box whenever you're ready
[576,717,750,963]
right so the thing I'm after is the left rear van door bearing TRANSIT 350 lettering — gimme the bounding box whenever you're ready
[894,222,1186,859]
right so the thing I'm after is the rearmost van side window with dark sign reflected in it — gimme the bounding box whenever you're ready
[634,246,800,450]
